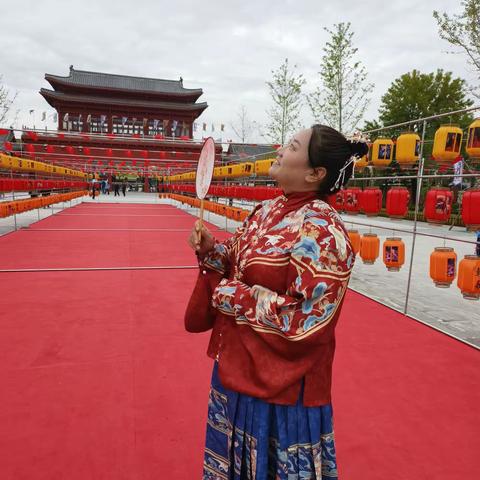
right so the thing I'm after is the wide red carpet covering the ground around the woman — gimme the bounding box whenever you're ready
[0,204,480,480]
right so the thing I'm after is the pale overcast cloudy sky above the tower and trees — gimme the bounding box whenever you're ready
[0,0,478,141]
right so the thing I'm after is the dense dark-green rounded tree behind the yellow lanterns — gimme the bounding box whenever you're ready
[363,70,473,138]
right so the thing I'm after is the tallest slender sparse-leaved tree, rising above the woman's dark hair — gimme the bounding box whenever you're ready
[307,23,374,133]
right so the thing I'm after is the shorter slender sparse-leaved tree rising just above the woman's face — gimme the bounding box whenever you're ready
[265,58,306,145]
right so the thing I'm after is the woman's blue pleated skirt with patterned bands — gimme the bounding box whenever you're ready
[203,362,338,480]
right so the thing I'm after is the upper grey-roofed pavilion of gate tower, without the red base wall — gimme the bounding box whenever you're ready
[40,66,208,138]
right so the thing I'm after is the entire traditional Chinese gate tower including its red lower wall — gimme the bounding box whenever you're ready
[17,66,222,186]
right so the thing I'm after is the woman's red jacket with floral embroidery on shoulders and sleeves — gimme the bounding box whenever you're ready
[186,192,355,406]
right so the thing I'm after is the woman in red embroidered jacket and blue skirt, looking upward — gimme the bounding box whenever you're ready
[185,125,368,480]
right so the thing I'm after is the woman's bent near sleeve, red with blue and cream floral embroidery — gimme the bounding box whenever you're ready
[212,208,355,341]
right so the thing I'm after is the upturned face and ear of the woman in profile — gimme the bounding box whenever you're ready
[268,128,326,193]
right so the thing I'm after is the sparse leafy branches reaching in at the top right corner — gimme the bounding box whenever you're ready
[433,0,480,98]
